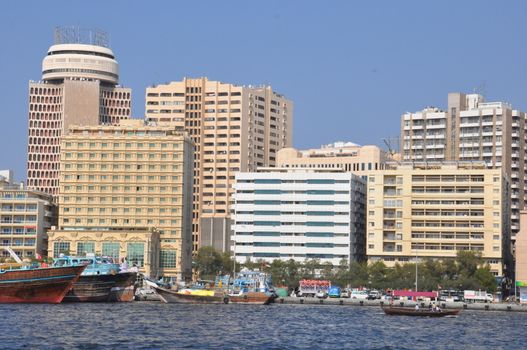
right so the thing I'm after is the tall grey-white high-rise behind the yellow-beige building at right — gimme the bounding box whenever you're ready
[401,93,527,239]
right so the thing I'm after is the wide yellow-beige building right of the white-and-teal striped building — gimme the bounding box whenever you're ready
[366,162,512,276]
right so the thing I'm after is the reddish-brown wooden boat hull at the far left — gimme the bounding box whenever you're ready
[0,266,85,303]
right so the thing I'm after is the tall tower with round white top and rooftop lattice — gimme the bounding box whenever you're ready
[27,28,131,199]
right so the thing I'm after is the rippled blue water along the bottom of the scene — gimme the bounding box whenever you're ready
[0,302,527,350]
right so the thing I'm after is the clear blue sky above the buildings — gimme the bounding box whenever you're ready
[0,0,527,180]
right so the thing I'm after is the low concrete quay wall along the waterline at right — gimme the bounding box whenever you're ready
[274,297,527,312]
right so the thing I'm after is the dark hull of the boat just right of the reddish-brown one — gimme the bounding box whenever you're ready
[63,272,137,302]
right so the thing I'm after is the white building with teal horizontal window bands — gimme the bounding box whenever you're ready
[233,168,365,265]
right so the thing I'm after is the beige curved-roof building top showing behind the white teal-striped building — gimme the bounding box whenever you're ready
[276,142,390,177]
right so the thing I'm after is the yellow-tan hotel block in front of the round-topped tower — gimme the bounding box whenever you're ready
[49,120,193,279]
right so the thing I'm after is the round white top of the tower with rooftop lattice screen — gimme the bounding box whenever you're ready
[42,27,119,85]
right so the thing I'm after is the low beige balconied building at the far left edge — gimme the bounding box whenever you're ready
[0,171,57,258]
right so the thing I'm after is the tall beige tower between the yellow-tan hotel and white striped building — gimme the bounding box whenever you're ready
[146,78,293,251]
